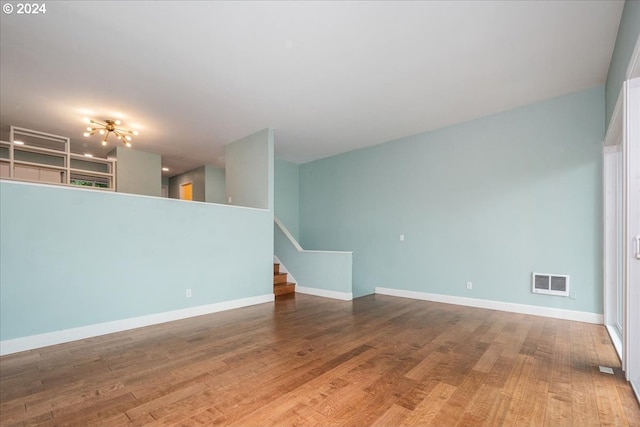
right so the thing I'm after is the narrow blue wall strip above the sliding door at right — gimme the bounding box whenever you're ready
[606,0,640,126]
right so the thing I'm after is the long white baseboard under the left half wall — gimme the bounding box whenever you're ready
[0,294,274,356]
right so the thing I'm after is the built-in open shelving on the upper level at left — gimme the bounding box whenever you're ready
[0,126,116,191]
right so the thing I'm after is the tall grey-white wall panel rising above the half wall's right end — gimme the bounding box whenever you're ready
[225,129,274,211]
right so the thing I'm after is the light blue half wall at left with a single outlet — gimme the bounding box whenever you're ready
[0,181,273,341]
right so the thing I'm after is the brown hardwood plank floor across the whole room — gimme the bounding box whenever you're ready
[0,294,640,427]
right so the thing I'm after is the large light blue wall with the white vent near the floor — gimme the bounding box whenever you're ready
[300,87,604,313]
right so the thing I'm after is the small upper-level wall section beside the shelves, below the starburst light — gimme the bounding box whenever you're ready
[109,147,162,197]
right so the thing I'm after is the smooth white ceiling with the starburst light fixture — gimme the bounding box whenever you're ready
[0,0,623,175]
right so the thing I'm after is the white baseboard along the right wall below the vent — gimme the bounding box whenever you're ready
[375,287,604,325]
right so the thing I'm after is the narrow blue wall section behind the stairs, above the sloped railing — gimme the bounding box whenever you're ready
[274,159,300,240]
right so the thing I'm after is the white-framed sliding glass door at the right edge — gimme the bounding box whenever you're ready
[603,78,640,400]
